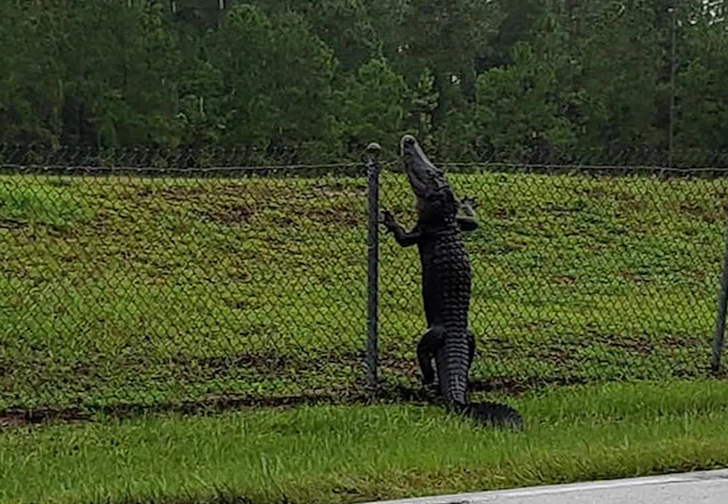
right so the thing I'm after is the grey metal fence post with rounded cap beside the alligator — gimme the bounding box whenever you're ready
[365,143,381,389]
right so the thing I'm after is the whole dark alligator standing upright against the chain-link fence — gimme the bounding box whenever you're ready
[382,135,523,429]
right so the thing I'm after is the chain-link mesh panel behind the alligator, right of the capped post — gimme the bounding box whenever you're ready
[380,166,728,390]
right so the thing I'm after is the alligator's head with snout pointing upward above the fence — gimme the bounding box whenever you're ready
[400,135,458,222]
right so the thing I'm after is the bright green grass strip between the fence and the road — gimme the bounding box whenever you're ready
[0,381,728,504]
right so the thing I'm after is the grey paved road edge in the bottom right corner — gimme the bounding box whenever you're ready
[370,469,728,504]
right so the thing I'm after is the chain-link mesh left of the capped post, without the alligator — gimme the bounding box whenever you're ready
[0,161,367,409]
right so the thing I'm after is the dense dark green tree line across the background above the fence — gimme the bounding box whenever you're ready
[0,0,728,165]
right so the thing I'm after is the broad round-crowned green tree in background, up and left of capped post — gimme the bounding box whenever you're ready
[201,4,336,154]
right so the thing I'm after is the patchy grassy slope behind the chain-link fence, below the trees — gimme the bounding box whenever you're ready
[0,169,728,409]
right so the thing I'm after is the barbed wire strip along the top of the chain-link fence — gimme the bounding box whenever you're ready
[0,143,728,170]
